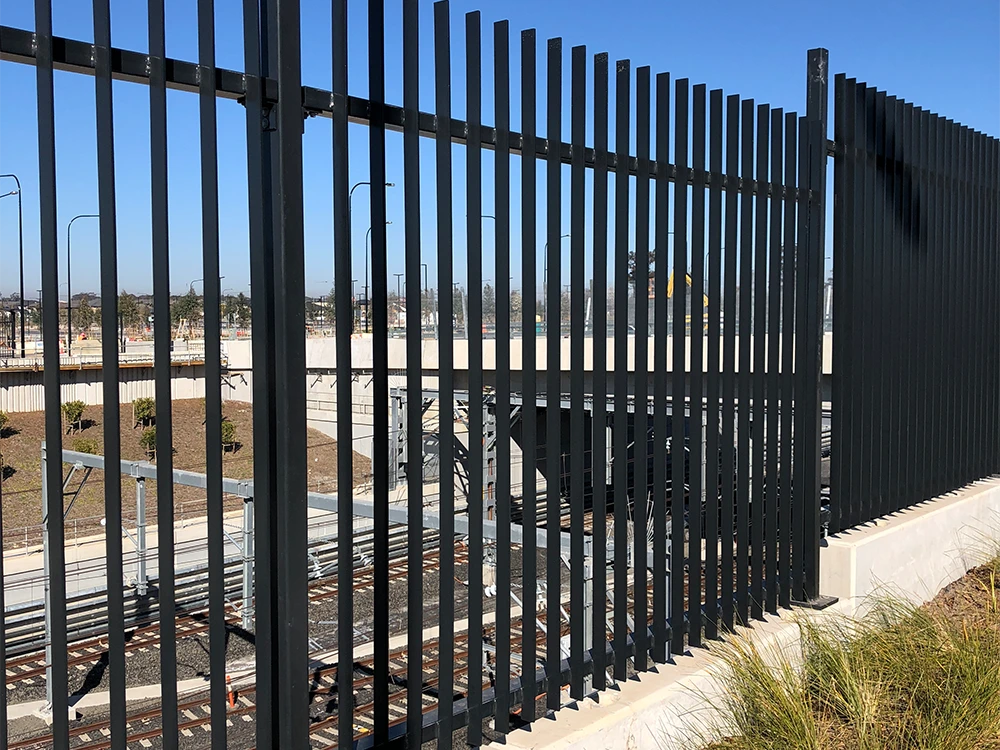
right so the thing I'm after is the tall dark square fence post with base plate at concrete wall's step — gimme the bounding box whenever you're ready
[793,48,837,609]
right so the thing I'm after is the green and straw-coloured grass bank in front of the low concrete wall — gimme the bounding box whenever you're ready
[709,558,1000,750]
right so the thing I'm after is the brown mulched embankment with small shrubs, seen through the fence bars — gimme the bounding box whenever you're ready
[0,399,371,547]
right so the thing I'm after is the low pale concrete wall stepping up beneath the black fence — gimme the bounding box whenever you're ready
[496,479,1000,750]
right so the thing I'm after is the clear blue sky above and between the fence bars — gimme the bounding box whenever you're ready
[0,0,1000,297]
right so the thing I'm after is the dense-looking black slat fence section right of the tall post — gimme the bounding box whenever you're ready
[831,76,1000,531]
